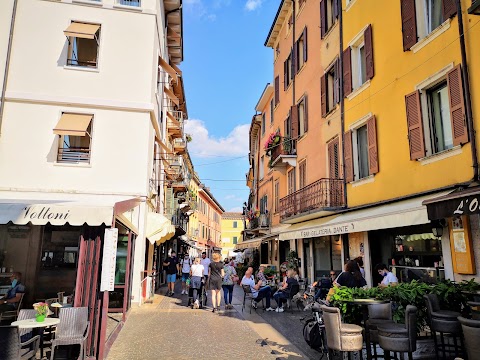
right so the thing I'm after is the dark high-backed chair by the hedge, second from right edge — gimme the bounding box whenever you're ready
[423,294,464,360]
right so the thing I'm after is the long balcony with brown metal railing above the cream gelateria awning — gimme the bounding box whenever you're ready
[279,179,345,223]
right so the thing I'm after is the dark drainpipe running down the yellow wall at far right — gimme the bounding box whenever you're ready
[455,0,478,181]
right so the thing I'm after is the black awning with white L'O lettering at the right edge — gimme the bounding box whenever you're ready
[423,186,480,220]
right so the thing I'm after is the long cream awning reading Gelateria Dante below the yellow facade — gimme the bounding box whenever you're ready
[279,192,447,240]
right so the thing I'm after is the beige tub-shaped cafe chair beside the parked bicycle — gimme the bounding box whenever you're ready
[320,305,363,359]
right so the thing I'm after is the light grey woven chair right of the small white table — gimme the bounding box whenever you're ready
[50,307,90,360]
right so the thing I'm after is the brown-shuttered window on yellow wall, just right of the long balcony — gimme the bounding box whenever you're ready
[344,116,379,182]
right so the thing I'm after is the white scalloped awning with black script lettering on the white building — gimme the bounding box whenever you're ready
[0,192,137,226]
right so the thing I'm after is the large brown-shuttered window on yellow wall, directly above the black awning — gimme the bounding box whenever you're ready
[405,65,468,160]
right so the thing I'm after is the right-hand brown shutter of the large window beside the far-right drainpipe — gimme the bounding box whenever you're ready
[447,65,468,146]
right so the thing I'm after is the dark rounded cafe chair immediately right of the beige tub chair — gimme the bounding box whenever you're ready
[377,305,417,360]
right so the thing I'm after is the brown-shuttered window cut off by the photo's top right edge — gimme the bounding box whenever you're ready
[401,0,457,51]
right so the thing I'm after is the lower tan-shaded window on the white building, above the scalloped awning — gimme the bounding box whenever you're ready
[53,113,93,164]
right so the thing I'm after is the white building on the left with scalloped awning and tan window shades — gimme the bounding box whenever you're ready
[0,0,186,358]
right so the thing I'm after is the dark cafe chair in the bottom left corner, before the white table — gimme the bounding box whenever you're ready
[0,326,40,360]
